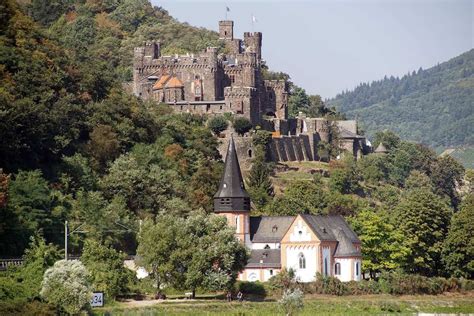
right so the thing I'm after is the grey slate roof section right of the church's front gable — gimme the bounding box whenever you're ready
[301,214,360,243]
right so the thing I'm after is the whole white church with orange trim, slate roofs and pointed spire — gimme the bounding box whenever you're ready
[214,138,362,282]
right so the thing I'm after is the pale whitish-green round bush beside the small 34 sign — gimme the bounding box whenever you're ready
[40,260,92,314]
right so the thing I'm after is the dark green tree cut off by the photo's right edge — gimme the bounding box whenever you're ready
[443,193,474,279]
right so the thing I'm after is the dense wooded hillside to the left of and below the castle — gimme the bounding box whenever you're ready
[0,0,226,257]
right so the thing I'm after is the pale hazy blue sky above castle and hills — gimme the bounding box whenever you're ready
[152,0,474,98]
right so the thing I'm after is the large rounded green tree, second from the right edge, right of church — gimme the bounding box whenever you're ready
[392,188,452,276]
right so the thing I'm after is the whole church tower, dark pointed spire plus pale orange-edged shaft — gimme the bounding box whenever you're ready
[214,137,250,244]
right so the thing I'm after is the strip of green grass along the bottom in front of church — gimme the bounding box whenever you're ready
[94,292,474,316]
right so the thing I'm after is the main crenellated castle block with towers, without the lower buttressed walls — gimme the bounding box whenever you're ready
[133,21,288,126]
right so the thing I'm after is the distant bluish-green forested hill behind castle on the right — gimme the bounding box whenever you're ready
[328,50,474,148]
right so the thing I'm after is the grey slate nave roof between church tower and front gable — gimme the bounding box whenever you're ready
[250,216,295,243]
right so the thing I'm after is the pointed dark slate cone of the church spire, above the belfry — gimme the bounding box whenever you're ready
[214,137,250,198]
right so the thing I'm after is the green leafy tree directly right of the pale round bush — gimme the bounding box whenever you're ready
[81,239,130,299]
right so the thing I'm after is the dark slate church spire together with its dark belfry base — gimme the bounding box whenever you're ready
[214,137,250,212]
